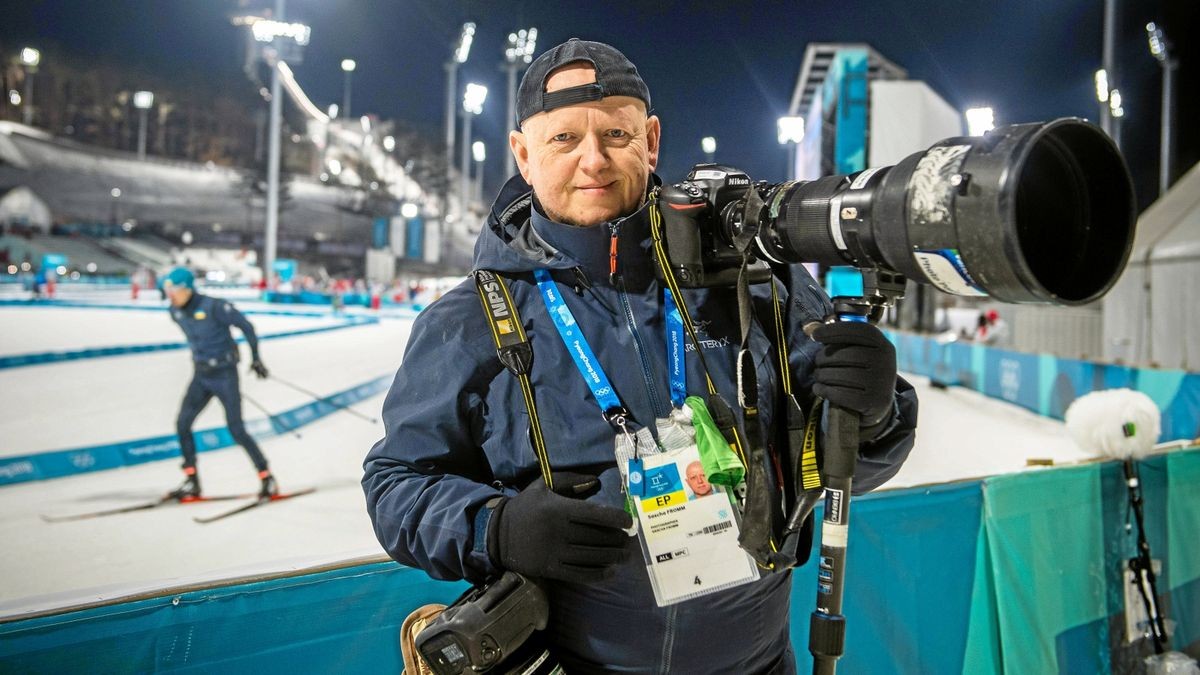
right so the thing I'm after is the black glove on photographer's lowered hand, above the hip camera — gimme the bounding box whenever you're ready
[487,473,632,583]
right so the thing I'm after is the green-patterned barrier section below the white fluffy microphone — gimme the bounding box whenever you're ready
[966,450,1200,674]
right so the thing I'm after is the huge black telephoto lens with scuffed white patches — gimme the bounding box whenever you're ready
[746,118,1136,305]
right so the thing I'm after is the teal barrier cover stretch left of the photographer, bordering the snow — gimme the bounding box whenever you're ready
[0,562,466,675]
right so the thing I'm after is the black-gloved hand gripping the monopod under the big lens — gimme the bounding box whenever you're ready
[812,321,896,441]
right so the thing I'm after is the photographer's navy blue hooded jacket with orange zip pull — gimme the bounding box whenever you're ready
[362,178,917,673]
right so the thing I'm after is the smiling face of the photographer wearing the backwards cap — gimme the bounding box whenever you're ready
[509,64,660,226]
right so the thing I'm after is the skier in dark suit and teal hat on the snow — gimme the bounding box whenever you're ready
[162,267,280,502]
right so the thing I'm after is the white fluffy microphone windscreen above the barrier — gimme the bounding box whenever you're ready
[1064,389,1162,460]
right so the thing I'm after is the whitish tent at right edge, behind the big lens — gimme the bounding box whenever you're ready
[1104,159,1200,370]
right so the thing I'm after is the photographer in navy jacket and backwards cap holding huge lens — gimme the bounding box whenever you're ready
[362,40,916,674]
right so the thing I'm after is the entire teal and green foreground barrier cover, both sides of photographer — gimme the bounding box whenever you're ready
[0,449,1200,675]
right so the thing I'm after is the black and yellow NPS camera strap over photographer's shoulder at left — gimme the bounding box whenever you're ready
[474,269,554,490]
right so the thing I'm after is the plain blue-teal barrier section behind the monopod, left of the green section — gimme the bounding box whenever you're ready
[792,480,982,675]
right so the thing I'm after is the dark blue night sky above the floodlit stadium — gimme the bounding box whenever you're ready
[0,0,1200,205]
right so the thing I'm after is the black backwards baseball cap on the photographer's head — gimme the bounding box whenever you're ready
[517,37,650,126]
